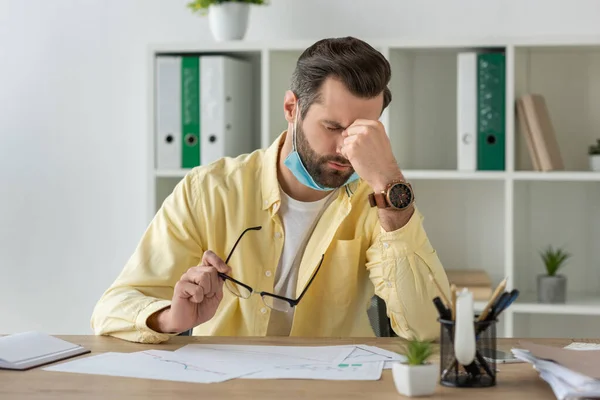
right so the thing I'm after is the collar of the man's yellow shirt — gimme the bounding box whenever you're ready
[261,131,362,210]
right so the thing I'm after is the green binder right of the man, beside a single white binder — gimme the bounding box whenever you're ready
[477,52,506,171]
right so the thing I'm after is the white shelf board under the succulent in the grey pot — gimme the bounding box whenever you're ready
[510,292,600,315]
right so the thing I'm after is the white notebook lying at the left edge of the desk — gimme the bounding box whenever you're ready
[0,332,91,370]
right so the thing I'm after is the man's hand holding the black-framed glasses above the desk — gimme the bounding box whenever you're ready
[148,250,231,333]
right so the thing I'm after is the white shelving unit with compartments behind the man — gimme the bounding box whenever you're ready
[148,37,600,337]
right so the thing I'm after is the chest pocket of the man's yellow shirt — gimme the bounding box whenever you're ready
[326,237,366,306]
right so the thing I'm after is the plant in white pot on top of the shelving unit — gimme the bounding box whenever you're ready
[187,0,267,41]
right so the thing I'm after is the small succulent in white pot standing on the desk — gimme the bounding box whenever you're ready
[392,340,438,397]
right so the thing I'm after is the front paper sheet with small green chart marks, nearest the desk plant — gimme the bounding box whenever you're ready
[241,361,383,381]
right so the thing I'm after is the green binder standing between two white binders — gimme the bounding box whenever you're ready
[181,56,200,168]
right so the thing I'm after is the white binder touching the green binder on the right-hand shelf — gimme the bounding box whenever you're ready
[456,52,477,171]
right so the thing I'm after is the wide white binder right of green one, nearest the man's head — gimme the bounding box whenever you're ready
[200,55,254,165]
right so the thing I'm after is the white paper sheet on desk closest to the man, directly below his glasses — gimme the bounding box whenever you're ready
[175,344,354,369]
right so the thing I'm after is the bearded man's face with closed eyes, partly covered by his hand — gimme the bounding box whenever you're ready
[296,79,383,188]
